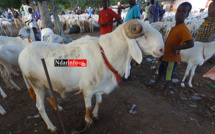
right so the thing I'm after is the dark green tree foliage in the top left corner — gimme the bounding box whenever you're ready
[0,0,24,9]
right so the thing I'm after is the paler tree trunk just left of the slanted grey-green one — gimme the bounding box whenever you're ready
[38,0,53,29]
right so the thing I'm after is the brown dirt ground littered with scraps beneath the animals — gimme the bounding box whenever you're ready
[0,25,215,134]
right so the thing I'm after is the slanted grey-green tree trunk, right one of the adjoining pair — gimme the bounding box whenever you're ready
[49,0,69,43]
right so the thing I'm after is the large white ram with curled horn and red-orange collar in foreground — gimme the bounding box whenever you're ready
[18,19,164,132]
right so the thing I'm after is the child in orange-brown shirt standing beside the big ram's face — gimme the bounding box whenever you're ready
[150,2,194,96]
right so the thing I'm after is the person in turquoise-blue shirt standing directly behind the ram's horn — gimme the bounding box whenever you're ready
[125,0,140,22]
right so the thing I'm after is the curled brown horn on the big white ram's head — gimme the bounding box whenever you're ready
[124,19,143,39]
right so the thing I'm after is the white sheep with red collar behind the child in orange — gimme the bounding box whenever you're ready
[180,41,215,88]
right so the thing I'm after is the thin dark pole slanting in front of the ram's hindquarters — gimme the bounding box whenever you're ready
[41,59,66,134]
